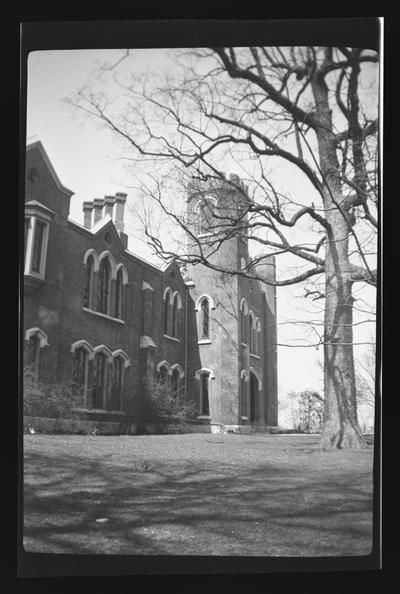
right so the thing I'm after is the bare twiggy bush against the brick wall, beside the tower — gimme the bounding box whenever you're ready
[150,380,195,425]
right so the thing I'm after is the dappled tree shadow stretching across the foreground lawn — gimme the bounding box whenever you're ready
[24,442,372,556]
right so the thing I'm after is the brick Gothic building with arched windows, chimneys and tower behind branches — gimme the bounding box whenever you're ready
[23,141,277,425]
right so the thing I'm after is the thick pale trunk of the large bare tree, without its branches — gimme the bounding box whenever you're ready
[311,71,366,449]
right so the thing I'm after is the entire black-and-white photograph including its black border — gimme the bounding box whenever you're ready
[19,17,383,575]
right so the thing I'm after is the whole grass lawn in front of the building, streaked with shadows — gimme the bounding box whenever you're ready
[24,434,373,556]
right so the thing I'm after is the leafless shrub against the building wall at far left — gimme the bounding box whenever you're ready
[23,365,82,419]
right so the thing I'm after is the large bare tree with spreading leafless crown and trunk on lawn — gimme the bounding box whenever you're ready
[65,47,378,448]
